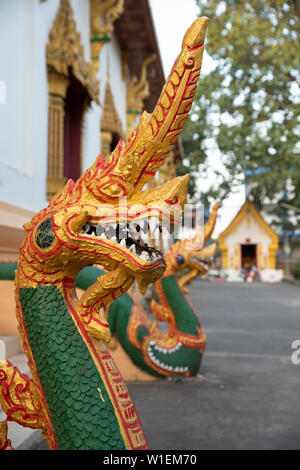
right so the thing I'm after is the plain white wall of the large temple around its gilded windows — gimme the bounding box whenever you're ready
[0,0,126,211]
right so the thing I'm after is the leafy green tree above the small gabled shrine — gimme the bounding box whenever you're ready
[178,0,300,231]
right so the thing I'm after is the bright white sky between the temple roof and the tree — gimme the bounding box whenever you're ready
[149,0,245,237]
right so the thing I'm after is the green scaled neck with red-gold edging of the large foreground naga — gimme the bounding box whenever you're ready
[18,285,147,450]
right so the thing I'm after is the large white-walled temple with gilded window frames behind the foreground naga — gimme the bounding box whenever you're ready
[0,0,182,335]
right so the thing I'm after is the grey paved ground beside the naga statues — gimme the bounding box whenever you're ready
[34,280,300,450]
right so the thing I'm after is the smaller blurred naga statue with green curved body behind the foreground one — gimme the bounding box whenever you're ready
[76,204,218,378]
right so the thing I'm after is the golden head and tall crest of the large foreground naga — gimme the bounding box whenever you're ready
[19,18,208,303]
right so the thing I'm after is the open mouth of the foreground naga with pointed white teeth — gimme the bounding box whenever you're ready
[81,217,170,263]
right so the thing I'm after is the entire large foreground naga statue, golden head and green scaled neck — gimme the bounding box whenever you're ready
[0,18,208,450]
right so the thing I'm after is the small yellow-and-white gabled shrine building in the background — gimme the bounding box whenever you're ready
[218,199,282,280]
